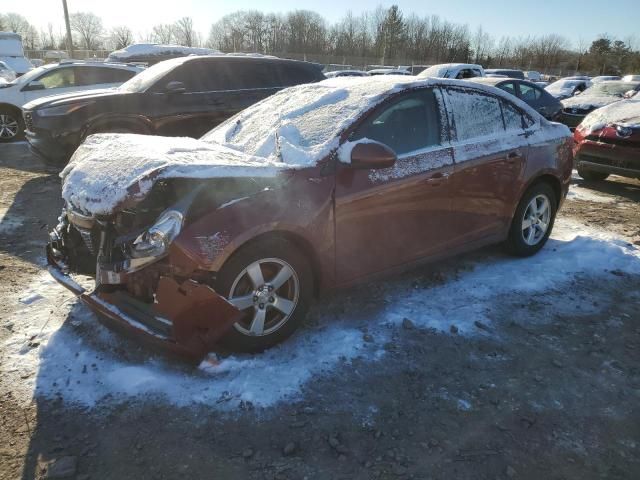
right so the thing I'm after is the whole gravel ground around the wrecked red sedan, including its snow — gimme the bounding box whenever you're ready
[0,144,640,479]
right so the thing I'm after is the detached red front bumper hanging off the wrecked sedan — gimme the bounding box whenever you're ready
[46,244,242,363]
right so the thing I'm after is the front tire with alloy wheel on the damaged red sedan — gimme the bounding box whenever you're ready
[215,238,314,352]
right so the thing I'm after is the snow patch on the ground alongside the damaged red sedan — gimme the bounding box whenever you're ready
[0,219,640,410]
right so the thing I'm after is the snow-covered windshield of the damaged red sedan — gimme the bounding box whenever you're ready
[202,79,398,165]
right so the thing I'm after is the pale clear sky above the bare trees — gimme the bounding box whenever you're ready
[8,0,640,47]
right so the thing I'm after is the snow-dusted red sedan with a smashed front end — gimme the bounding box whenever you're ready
[48,76,573,357]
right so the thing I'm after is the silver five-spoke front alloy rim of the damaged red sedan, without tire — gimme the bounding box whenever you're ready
[228,258,300,336]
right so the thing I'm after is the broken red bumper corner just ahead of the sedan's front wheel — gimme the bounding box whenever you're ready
[155,277,242,354]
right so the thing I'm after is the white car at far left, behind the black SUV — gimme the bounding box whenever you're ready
[0,61,143,143]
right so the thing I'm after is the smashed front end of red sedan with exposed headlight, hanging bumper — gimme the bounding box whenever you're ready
[47,182,252,361]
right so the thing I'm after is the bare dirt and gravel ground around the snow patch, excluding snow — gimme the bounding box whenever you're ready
[0,144,640,480]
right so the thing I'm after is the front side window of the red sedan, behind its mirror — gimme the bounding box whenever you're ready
[351,89,441,155]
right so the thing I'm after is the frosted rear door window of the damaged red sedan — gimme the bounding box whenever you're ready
[445,88,505,141]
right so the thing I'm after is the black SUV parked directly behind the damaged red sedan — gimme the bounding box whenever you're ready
[23,55,325,164]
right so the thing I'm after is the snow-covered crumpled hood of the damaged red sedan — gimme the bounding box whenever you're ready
[60,133,291,216]
